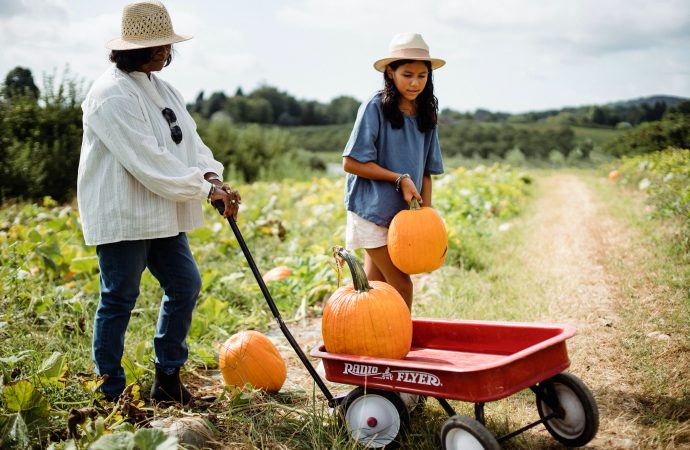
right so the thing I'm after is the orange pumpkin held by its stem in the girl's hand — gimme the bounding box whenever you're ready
[388,197,448,275]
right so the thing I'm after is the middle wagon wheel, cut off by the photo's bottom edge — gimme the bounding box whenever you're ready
[441,414,501,450]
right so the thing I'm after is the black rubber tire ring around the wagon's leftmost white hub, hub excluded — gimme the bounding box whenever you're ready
[341,387,410,449]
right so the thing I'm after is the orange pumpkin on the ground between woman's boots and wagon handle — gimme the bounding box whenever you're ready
[218,331,287,392]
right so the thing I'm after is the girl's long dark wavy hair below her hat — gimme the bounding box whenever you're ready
[381,59,438,133]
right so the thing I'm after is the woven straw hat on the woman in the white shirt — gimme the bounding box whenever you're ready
[105,0,192,50]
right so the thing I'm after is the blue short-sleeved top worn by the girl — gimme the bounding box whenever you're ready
[343,94,443,227]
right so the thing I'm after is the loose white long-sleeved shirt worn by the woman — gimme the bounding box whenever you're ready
[77,66,223,245]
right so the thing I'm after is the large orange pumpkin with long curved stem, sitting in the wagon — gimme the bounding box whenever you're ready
[321,247,412,359]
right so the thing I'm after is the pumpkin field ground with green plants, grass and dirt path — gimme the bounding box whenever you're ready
[0,159,690,449]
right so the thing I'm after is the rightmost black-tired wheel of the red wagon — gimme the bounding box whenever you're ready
[537,372,599,447]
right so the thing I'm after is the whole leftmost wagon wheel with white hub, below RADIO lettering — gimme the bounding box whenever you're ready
[342,387,410,448]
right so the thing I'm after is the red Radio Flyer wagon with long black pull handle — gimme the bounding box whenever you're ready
[214,202,599,450]
